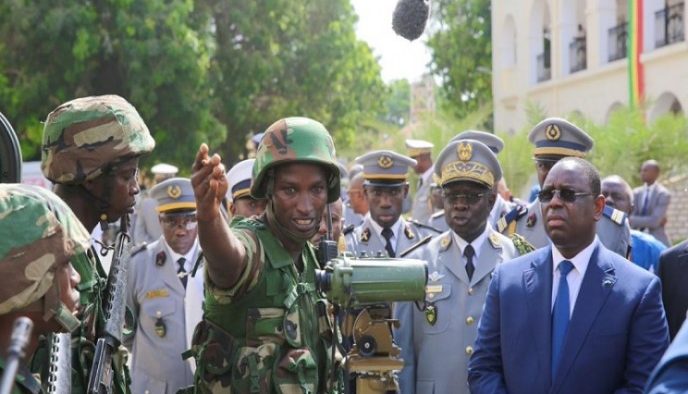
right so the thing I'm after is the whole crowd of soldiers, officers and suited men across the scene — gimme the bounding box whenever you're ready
[0,96,688,394]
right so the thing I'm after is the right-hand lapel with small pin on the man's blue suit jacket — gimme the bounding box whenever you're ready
[552,244,616,389]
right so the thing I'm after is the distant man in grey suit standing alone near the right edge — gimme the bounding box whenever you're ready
[630,160,671,246]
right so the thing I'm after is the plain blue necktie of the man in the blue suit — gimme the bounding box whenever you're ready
[552,260,573,380]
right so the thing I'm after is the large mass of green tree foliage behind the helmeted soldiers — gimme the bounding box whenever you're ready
[0,0,386,169]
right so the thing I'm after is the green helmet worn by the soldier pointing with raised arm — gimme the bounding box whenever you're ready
[251,117,340,203]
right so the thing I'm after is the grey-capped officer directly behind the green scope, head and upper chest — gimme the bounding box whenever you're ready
[346,150,425,257]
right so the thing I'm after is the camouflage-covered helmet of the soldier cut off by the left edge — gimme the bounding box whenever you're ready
[0,184,90,331]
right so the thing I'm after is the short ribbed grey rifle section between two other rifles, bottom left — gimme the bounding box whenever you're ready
[44,333,72,394]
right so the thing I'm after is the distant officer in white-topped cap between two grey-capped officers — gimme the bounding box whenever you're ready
[406,139,434,223]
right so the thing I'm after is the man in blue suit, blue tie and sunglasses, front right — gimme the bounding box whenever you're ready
[468,158,669,394]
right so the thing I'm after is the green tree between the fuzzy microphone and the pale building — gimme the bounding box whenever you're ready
[428,0,492,117]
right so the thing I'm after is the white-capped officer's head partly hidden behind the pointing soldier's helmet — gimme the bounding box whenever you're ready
[225,159,267,218]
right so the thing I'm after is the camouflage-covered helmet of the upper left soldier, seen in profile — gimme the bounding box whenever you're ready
[41,95,155,185]
